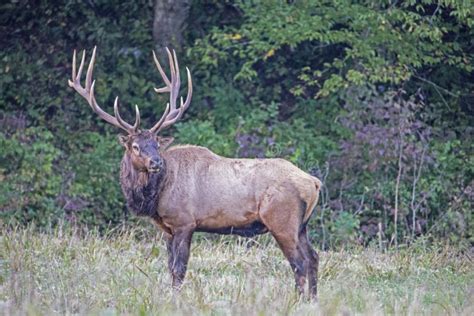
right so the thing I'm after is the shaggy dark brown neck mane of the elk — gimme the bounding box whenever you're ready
[120,153,165,218]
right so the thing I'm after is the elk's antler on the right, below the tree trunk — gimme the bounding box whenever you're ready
[150,48,193,133]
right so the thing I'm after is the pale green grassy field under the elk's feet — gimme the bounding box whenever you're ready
[0,223,474,315]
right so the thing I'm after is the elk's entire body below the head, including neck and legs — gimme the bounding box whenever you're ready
[121,145,321,296]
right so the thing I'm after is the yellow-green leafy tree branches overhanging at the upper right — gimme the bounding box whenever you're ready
[197,0,474,96]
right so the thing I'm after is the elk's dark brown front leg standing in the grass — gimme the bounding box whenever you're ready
[167,228,194,288]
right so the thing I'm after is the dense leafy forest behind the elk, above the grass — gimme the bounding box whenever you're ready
[0,0,474,249]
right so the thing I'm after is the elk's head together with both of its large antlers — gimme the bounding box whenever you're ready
[69,47,193,173]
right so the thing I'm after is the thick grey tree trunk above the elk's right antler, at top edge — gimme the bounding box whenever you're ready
[153,0,191,55]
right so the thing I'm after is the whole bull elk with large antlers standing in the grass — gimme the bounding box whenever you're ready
[69,48,321,297]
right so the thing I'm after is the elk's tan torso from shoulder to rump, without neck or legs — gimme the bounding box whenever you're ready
[157,146,321,230]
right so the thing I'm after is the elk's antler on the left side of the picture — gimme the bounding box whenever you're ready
[68,47,140,134]
